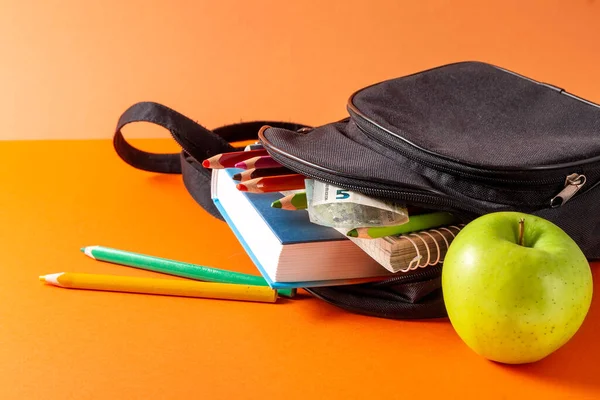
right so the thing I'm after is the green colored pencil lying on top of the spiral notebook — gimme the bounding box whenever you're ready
[346,211,456,239]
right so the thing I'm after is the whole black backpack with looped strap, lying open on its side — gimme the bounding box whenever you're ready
[114,62,600,319]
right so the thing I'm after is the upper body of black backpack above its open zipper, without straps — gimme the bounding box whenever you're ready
[259,63,600,259]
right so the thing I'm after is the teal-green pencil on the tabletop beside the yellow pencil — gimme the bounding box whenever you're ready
[81,246,296,297]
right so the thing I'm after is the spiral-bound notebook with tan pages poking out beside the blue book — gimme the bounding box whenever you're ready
[338,225,464,273]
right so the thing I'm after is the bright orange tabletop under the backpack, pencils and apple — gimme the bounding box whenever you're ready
[0,140,600,400]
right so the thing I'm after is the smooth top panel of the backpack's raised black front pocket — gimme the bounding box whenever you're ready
[350,62,600,169]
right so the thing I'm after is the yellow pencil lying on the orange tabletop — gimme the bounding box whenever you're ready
[40,272,277,303]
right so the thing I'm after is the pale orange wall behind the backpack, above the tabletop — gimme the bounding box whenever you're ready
[0,0,600,139]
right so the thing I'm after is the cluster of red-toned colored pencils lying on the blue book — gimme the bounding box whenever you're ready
[202,144,306,198]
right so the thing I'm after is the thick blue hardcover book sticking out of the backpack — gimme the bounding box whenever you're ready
[211,168,392,289]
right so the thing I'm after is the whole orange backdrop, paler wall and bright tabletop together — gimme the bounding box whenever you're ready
[0,0,600,400]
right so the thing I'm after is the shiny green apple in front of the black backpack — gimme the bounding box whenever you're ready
[442,212,593,364]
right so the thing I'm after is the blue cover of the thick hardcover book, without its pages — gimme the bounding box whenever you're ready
[212,168,384,289]
